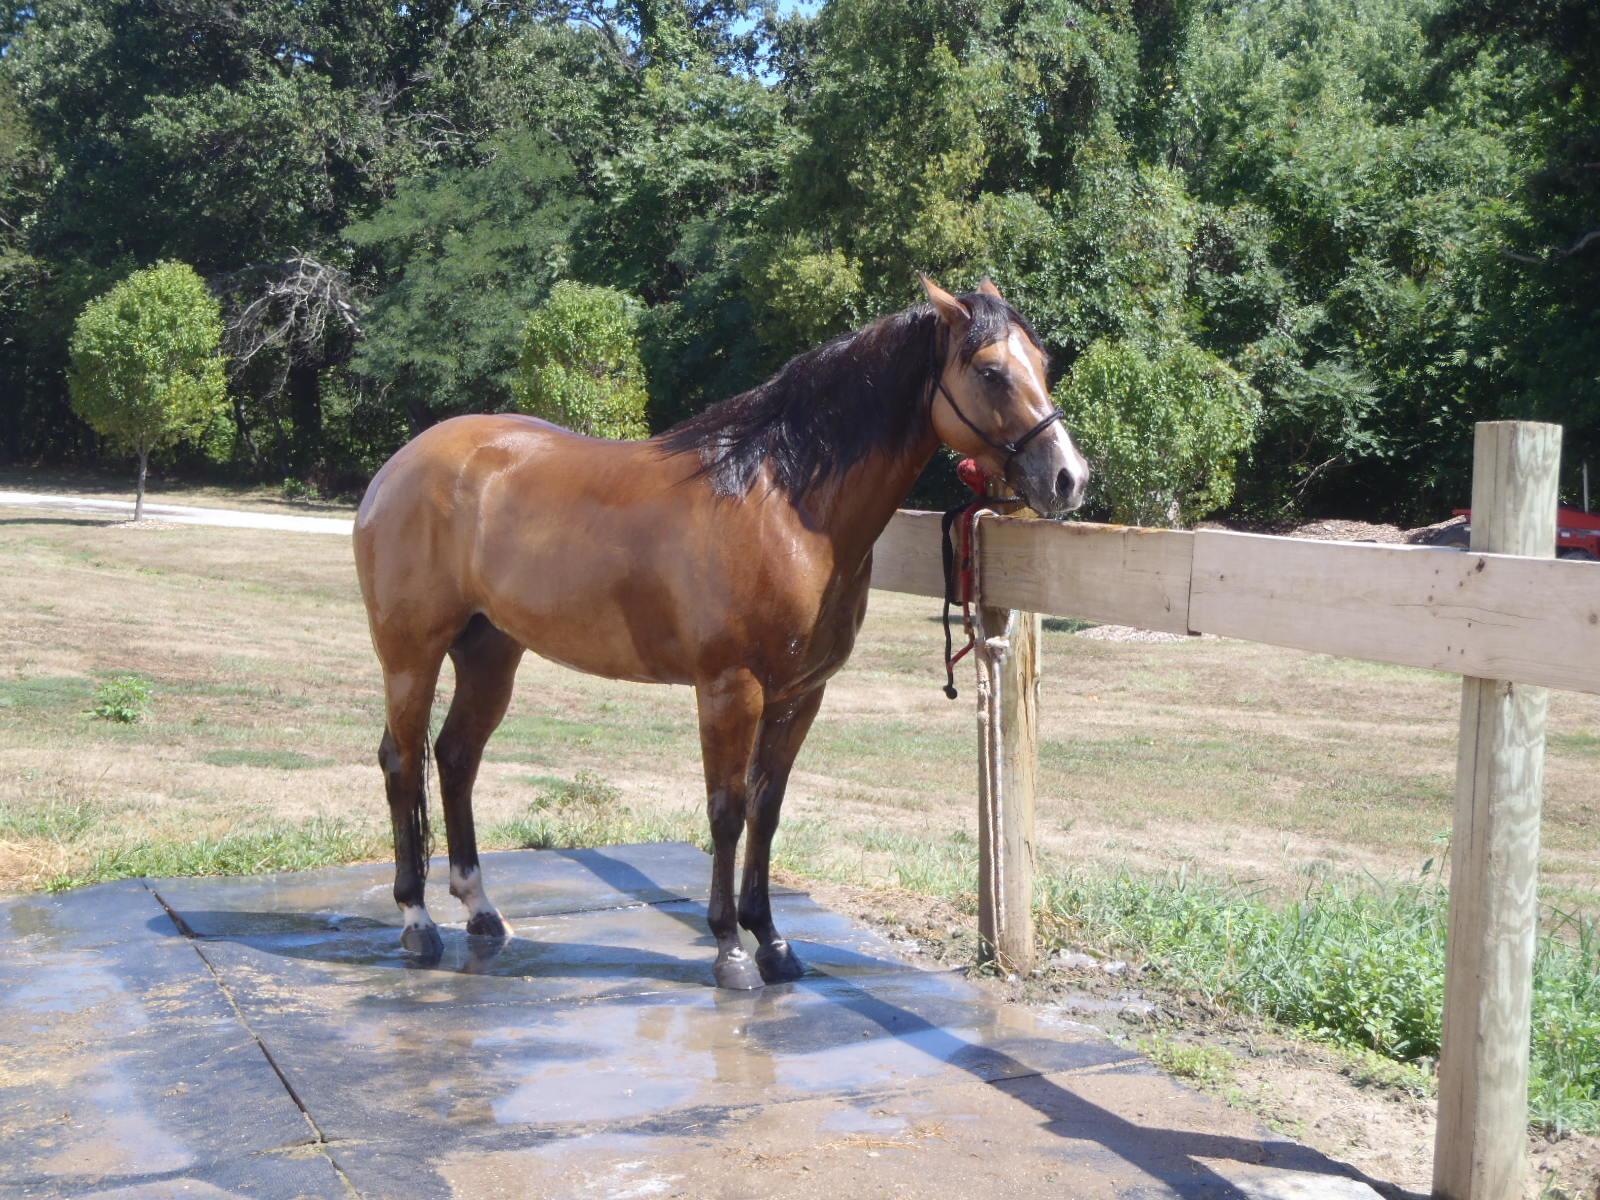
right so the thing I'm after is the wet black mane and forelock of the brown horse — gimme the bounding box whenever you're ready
[661,291,1038,501]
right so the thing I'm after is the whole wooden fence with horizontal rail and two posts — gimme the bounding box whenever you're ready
[872,421,1600,1200]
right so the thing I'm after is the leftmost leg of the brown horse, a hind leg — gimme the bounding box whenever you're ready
[378,646,445,962]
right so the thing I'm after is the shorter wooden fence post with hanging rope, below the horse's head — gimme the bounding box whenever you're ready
[973,518,1040,974]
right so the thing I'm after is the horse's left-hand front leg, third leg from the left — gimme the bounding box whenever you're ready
[696,669,763,990]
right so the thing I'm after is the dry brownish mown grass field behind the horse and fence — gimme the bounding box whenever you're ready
[0,510,1600,907]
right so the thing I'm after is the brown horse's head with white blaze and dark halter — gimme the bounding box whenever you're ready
[922,277,1090,517]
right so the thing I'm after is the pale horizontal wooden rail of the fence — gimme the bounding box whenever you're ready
[872,489,1600,693]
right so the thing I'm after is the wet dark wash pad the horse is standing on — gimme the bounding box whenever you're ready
[0,845,1376,1200]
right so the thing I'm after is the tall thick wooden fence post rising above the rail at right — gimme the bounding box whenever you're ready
[1434,421,1562,1200]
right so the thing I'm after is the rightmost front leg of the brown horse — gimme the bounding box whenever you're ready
[739,688,822,984]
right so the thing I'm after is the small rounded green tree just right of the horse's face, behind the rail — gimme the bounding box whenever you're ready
[1056,341,1261,525]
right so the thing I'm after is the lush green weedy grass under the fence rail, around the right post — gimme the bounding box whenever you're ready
[1037,874,1600,1133]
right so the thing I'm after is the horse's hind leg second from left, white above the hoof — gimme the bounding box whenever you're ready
[434,616,522,938]
